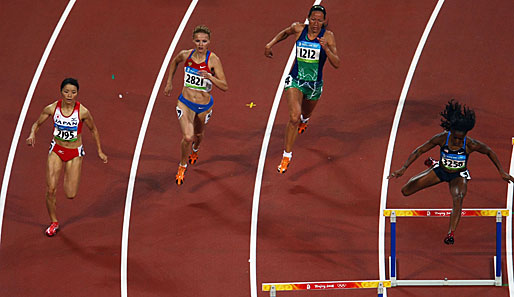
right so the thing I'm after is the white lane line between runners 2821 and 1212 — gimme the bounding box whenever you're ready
[248,0,321,297]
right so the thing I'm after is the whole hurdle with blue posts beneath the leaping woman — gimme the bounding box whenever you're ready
[383,209,509,287]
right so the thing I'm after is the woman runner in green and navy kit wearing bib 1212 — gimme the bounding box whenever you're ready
[264,5,340,173]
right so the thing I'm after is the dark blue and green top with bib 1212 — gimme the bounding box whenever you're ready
[290,25,327,82]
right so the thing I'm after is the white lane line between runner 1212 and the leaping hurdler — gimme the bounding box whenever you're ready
[378,0,444,296]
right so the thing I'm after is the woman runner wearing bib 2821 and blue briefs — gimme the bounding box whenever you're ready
[164,26,228,186]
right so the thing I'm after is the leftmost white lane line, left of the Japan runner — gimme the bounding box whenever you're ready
[0,0,76,241]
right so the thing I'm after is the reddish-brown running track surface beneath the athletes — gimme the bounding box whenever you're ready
[0,0,514,296]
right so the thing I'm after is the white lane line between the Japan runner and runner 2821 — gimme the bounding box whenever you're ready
[121,0,198,297]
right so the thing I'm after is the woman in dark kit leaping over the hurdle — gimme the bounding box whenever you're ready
[388,99,514,244]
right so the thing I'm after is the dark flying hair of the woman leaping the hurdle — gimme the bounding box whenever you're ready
[441,99,475,133]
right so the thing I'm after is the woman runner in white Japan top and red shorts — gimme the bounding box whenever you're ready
[26,78,107,236]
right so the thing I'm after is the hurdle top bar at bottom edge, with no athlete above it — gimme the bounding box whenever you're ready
[262,280,391,297]
